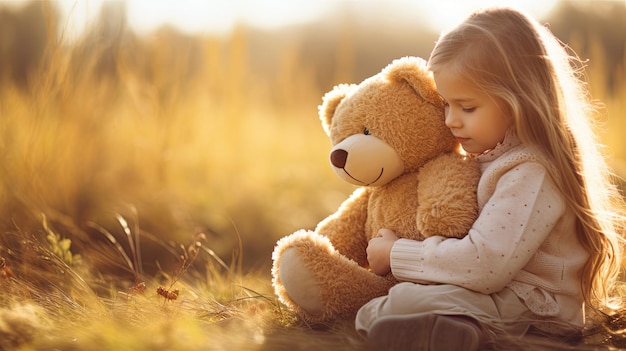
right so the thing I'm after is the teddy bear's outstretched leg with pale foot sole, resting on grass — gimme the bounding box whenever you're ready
[272,231,394,322]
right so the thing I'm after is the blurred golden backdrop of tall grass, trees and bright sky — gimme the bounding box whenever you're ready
[0,0,626,275]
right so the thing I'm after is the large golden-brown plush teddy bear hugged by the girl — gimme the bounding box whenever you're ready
[272,57,480,324]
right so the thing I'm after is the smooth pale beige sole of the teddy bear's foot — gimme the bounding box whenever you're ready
[278,248,323,315]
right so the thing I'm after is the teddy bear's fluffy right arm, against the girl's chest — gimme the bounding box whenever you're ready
[417,153,481,238]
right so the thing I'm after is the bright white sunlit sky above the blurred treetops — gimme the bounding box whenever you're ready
[57,0,560,36]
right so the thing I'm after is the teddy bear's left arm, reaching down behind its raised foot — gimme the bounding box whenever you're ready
[315,188,370,267]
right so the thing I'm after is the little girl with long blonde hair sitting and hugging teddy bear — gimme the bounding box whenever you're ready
[356,8,624,350]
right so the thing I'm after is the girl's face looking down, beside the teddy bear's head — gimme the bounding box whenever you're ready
[434,72,513,154]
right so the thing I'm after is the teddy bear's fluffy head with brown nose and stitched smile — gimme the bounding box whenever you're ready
[319,57,458,186]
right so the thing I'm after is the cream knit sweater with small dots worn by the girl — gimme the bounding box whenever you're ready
[391,135,588,326]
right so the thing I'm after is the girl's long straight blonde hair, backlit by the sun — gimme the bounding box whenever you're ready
[429,8,624,309]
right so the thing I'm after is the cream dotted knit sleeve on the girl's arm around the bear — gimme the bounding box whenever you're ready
[391,162,564,294]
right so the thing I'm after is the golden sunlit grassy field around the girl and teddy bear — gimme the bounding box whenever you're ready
[0,1,626,350]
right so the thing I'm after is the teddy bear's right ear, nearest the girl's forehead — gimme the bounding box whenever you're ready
[383,56,443,105]
